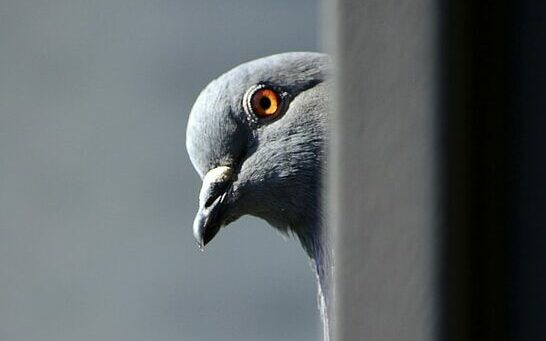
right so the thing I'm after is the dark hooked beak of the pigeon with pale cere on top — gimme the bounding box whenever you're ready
[193,166,234,249]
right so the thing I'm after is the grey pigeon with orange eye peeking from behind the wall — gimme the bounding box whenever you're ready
[186,52,332,340]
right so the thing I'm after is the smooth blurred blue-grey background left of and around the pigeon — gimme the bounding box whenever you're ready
[0,0,319,341]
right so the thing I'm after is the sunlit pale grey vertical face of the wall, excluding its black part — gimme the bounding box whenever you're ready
[330,0,438,341]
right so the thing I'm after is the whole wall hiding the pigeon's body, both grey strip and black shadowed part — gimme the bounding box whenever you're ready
[330,0,546,341]
